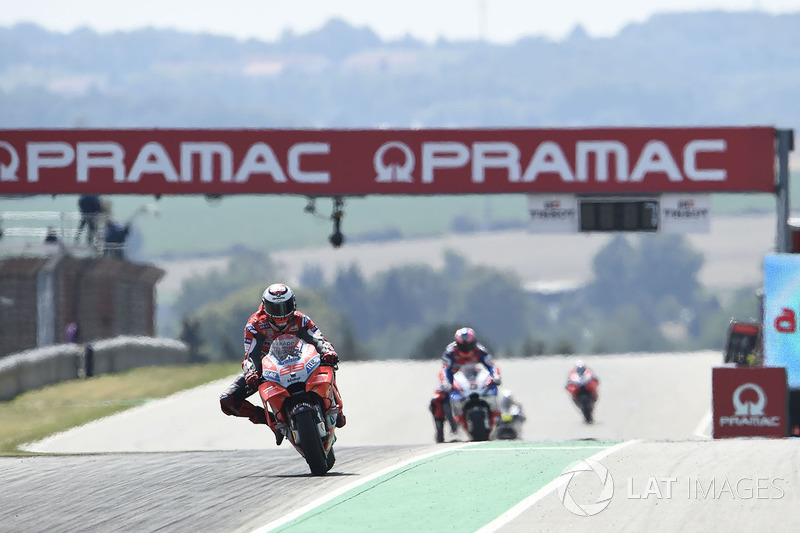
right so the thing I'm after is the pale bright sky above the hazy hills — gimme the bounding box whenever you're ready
[0,0,800,43]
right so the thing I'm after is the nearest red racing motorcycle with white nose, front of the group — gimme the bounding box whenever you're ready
[258,335,342,476]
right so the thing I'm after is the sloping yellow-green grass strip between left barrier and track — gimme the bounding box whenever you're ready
[0,362,241,455]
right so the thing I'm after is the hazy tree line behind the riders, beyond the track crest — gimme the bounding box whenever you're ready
[172,234,758,360]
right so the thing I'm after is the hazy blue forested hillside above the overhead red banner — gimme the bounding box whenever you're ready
[0,11,800,128]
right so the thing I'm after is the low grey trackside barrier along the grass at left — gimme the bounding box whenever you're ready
[0,337,189,401]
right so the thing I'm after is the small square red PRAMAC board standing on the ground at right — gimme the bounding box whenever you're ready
[712,367,787,439]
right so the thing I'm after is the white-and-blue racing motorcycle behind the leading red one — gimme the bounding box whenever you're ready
[450,364,500,441]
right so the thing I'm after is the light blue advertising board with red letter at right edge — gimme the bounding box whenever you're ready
[764,254,800,389]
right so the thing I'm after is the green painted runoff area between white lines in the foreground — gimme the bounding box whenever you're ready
[272,441,616,533]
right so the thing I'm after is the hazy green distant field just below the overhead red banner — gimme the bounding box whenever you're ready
[0,172,800,261]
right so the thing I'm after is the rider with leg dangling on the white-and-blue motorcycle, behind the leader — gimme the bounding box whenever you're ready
[430,327,501,442]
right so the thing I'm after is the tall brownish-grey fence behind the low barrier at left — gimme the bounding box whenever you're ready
[0,254,164,356]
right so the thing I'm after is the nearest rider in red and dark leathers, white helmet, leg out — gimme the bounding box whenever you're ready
[219,283,347,445]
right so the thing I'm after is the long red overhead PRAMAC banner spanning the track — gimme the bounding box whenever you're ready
[0,127,775,196]
